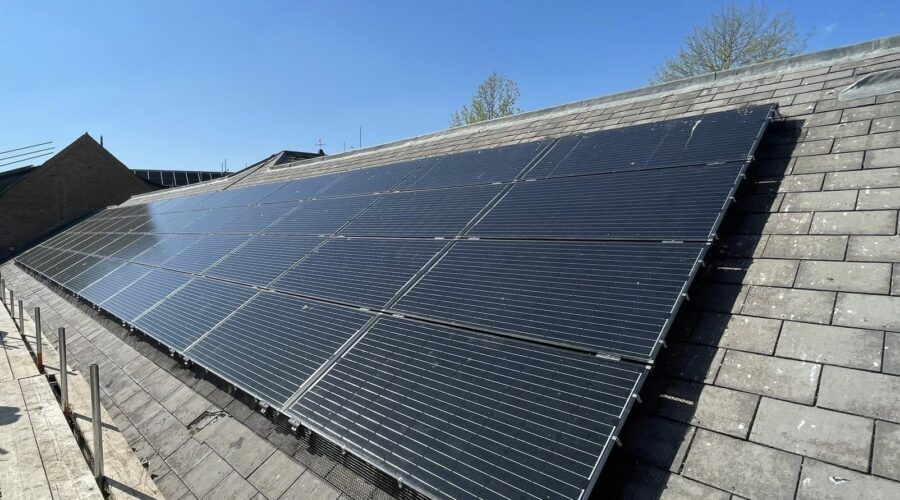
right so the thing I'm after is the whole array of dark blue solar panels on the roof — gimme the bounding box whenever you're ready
[18,106,773,499]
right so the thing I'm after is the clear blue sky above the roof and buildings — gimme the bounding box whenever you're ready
[0,0,900,170]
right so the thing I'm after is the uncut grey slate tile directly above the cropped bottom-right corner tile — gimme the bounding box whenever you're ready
[750,398,874,472]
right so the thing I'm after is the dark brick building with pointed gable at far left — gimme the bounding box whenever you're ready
[0,134,159,259]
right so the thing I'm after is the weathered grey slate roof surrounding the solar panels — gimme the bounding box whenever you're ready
[3,36,900,499]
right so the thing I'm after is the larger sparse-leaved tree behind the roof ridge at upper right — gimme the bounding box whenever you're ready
[651,2,806,83]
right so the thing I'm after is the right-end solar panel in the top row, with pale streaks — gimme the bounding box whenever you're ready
[528,104,774,177]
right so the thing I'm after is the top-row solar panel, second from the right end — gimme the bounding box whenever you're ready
[397,140,550,190]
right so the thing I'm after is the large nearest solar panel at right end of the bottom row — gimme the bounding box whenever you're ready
[289,317,646,499]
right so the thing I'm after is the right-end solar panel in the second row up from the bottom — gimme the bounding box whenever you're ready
[394,241,705,360]
